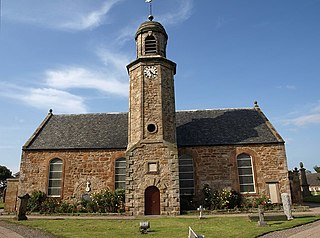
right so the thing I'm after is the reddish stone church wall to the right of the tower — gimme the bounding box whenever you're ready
[179,144,290,199]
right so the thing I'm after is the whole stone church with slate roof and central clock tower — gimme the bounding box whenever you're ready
[8,16,290,215]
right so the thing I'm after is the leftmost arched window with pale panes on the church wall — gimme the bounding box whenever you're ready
[48,158,63,197]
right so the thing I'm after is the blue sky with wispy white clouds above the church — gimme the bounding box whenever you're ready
[0,0,320,172]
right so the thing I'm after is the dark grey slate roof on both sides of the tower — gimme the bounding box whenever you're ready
[23,109,284,150]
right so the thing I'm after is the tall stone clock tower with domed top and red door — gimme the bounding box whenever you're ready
[126,16,180,215]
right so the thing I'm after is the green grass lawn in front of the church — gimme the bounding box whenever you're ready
[6,216,320,238]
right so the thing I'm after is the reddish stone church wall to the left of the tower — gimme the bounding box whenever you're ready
[19,150,125,201]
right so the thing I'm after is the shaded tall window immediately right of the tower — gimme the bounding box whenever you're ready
[179,155,194,195]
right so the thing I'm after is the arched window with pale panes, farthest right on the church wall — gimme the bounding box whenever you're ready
[237,154,255,193]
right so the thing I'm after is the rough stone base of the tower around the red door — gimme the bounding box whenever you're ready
[126,143,180,215]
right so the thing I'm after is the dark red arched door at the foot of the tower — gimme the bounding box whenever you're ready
[144,186,160,215]
